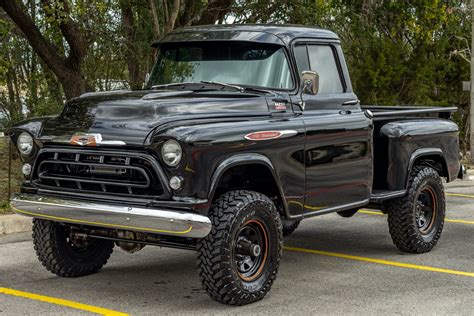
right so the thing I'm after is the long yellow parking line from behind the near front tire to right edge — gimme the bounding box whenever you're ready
[283,246,474,278]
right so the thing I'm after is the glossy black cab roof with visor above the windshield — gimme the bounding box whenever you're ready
[152,24,339,47]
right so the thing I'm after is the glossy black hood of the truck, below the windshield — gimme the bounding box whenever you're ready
[37,90,274,145]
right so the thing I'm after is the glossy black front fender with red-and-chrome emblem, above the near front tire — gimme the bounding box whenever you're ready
[151,116,305,215]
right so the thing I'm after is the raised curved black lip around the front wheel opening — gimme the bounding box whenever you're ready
[208,153,289,217]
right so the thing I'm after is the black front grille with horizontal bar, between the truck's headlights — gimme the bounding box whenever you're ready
[33,150,163,197]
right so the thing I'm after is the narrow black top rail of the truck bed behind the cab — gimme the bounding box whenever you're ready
[361,105,458,121]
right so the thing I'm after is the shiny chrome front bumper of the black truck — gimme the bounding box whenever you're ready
[10,193,212,238]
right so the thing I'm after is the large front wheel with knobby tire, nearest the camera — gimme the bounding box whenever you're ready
[197,190,283,305]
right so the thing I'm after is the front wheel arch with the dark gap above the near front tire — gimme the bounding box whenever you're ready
[208,154,288,218]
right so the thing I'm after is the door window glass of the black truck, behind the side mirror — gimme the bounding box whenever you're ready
[306,45,344,93]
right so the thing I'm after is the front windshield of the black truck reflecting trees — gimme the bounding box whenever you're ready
[147,41,293,89]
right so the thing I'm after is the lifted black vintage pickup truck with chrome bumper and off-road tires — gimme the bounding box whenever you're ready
[9,25,462,305]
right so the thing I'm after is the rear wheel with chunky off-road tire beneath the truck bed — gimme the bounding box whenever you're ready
[387,165,446,253]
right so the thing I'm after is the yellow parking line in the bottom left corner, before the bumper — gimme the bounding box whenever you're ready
[0,287,127,316]
